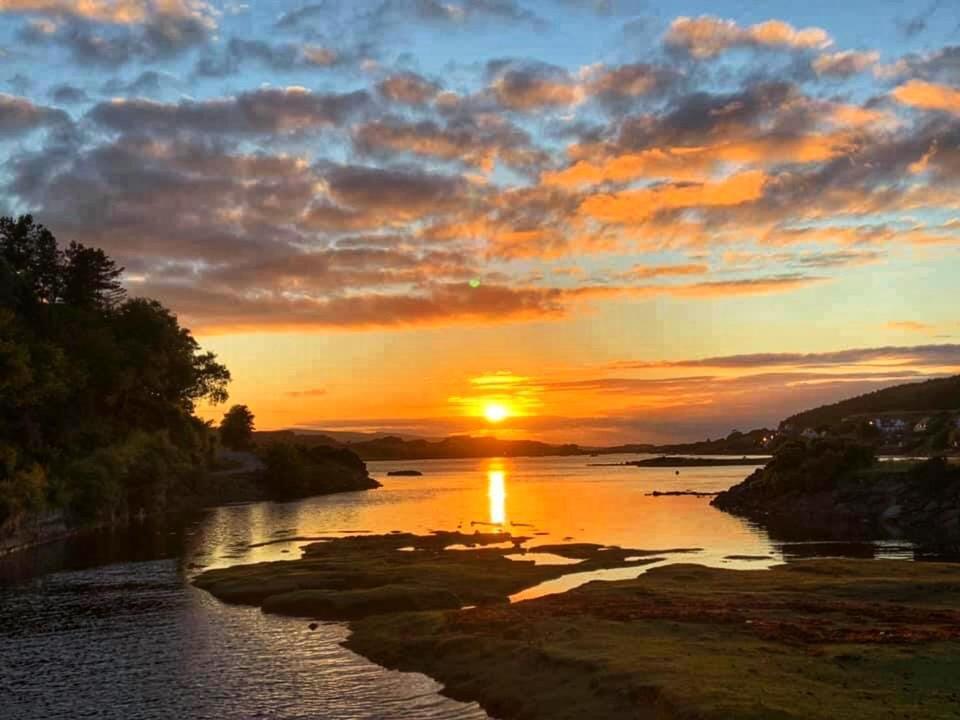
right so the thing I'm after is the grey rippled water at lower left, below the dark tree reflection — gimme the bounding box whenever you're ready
[0,560,487,720]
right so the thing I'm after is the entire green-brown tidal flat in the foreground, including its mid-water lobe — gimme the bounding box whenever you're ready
[195,533,960,720]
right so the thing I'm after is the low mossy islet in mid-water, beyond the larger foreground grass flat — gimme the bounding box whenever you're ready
[194,533,687,620]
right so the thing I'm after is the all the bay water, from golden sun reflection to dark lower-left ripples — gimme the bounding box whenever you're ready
[0,457,924,720]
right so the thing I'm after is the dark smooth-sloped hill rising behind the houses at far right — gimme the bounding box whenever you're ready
[780,375,960,431]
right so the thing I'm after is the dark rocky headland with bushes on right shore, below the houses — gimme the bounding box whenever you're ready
[712,441,960,542]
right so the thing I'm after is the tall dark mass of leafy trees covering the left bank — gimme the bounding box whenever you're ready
[0,215,230,529]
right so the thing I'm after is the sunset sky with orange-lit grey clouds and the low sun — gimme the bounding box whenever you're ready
[0,0,960,444]
